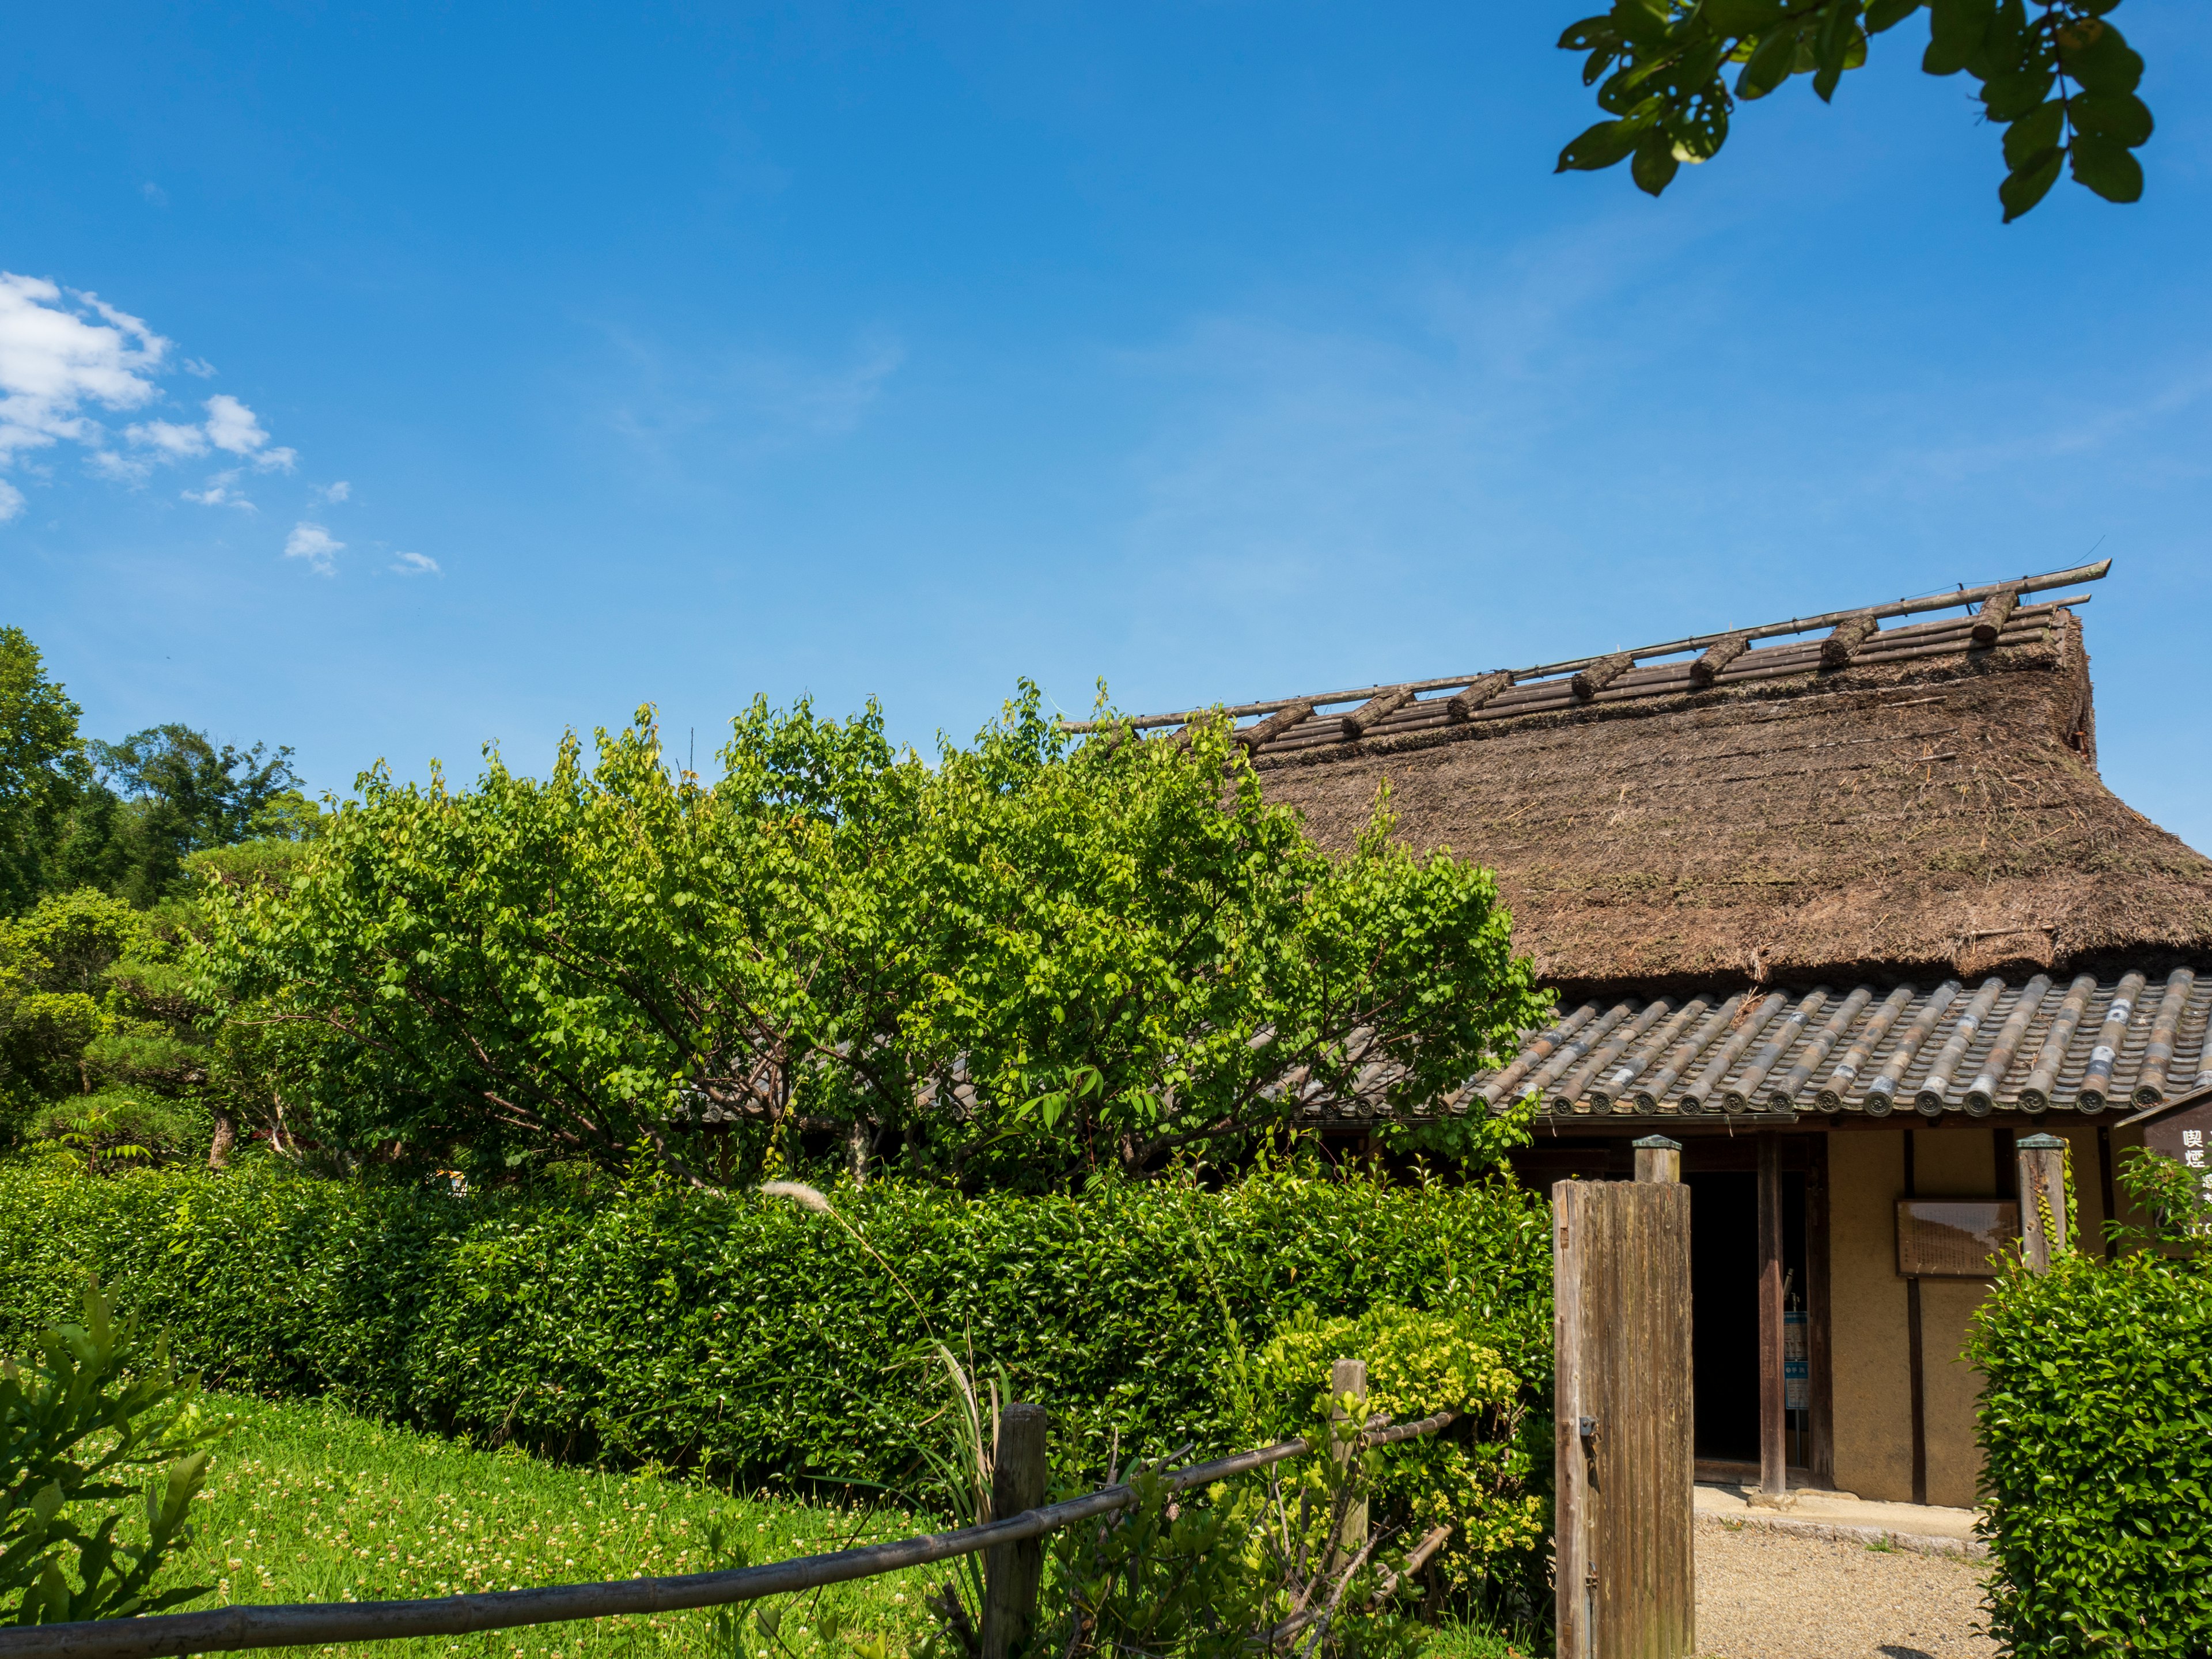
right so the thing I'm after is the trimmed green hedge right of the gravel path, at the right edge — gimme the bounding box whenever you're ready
[1969,1252,2212,1659]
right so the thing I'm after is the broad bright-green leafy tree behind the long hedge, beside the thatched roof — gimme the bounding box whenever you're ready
[197,688,1541,1185]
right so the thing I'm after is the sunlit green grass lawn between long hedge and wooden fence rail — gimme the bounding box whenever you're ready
[164,1393,1533,1659]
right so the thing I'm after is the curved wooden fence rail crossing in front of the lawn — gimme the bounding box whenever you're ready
[0,1411,1456,1659]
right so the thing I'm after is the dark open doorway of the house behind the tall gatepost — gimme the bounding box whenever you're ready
[1683,1170,1807,1467]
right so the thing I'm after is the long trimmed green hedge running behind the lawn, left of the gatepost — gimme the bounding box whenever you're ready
[0,1159,1551,1484]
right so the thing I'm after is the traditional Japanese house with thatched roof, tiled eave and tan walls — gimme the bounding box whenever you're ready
[1084,564,2212,1504]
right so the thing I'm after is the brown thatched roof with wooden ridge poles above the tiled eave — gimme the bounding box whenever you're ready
[1079,566,2212,1006]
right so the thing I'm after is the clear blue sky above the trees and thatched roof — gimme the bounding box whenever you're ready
[0,0,2212,847]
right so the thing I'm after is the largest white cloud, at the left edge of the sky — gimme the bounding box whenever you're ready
[0,272,168,467]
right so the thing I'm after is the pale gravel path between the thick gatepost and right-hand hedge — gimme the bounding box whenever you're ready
[1696,1522,1998,1659]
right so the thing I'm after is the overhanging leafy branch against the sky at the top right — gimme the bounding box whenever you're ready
[1559,0,2152,224]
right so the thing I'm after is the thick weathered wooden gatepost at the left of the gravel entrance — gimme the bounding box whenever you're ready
[1551,1137,1696,1659]
